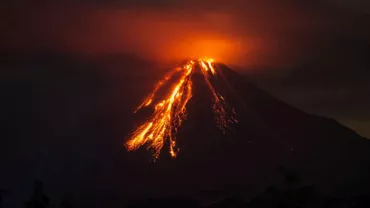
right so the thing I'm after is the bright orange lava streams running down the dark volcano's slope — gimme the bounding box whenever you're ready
[125,58,237,158]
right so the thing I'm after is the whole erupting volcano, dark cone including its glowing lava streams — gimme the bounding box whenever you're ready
[117,60,370,203]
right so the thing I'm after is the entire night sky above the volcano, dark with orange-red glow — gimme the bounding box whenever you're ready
[0,0,370,137]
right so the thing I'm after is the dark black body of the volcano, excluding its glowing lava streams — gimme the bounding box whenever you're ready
[115,61,370,202]
